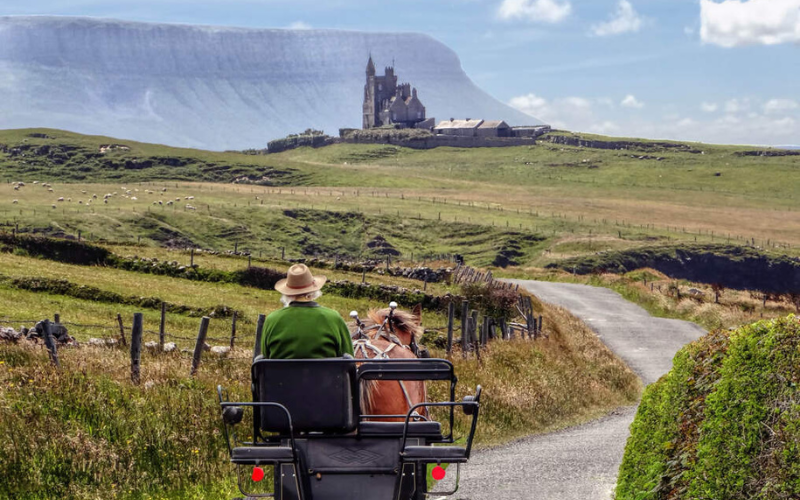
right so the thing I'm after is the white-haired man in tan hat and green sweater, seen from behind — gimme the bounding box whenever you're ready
[261,264,353,359]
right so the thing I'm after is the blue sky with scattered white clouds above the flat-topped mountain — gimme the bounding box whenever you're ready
[0,0,800,145]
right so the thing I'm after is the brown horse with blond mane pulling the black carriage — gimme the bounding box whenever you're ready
[353,306,427,422]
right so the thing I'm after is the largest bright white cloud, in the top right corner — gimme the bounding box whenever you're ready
[700,0,800,47]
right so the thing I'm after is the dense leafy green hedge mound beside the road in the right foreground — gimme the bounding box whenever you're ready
[616,316,800,500]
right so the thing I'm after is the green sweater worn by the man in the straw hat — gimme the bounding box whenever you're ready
[261,302,353,359]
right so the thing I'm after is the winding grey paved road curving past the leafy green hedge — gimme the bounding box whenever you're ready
[456,280,705,500]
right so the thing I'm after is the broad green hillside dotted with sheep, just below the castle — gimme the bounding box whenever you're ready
[0,130,800,265]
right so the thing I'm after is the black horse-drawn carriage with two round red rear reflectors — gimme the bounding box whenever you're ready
[218,304,481,500]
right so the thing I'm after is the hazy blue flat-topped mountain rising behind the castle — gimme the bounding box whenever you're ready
[0,17,539,150]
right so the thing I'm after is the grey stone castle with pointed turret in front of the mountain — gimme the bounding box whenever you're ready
[363,55,433,129]
